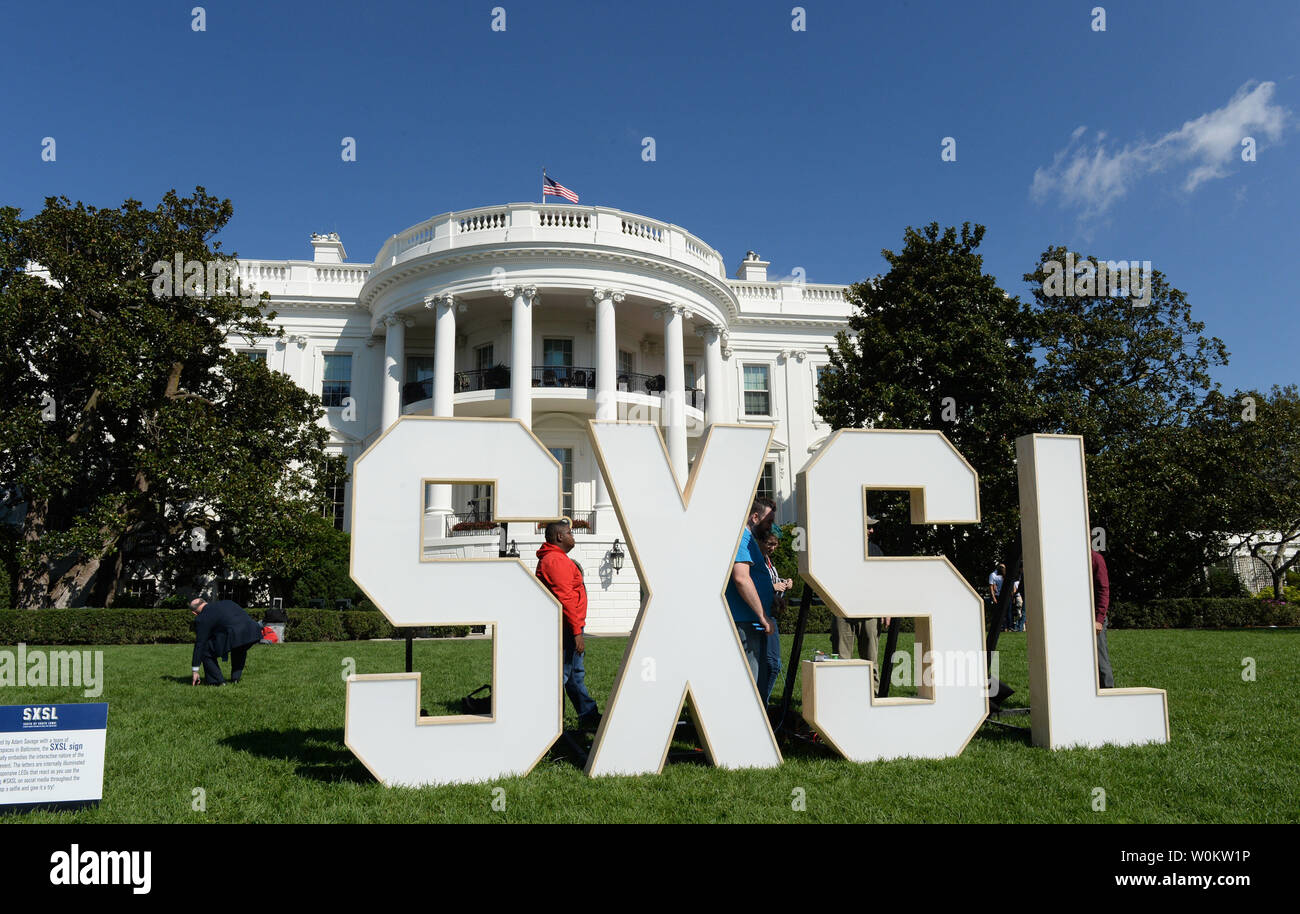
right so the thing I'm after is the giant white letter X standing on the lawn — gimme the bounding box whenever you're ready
[586,421,781,776]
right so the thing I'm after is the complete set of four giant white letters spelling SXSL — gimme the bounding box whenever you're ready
[346,416,1169,787]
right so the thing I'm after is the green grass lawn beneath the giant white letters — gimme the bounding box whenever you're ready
[0,629,1300,823]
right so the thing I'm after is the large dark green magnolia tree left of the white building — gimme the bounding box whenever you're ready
[0,187,337,608]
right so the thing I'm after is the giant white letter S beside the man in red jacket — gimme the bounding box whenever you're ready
[345,416,563,787]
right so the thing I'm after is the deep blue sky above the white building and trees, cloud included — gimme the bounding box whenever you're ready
[0,0,1300,387]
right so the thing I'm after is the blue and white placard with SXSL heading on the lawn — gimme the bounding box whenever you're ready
[0,703,108,813]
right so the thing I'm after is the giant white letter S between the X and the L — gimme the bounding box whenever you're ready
[798,430,988,762]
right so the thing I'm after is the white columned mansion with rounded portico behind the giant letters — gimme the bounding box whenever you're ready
[229,203,849,633]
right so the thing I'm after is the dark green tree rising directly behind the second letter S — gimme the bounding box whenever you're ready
[816,222,1039,586]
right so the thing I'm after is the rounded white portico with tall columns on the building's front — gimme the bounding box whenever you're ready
[359,204,737,545]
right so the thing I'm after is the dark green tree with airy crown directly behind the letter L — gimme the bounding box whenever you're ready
[1024,247,1231,599]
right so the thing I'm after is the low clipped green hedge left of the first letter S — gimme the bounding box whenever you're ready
[0,608,469,645]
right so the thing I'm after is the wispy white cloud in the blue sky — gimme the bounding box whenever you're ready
[1030,82,1294,220]
